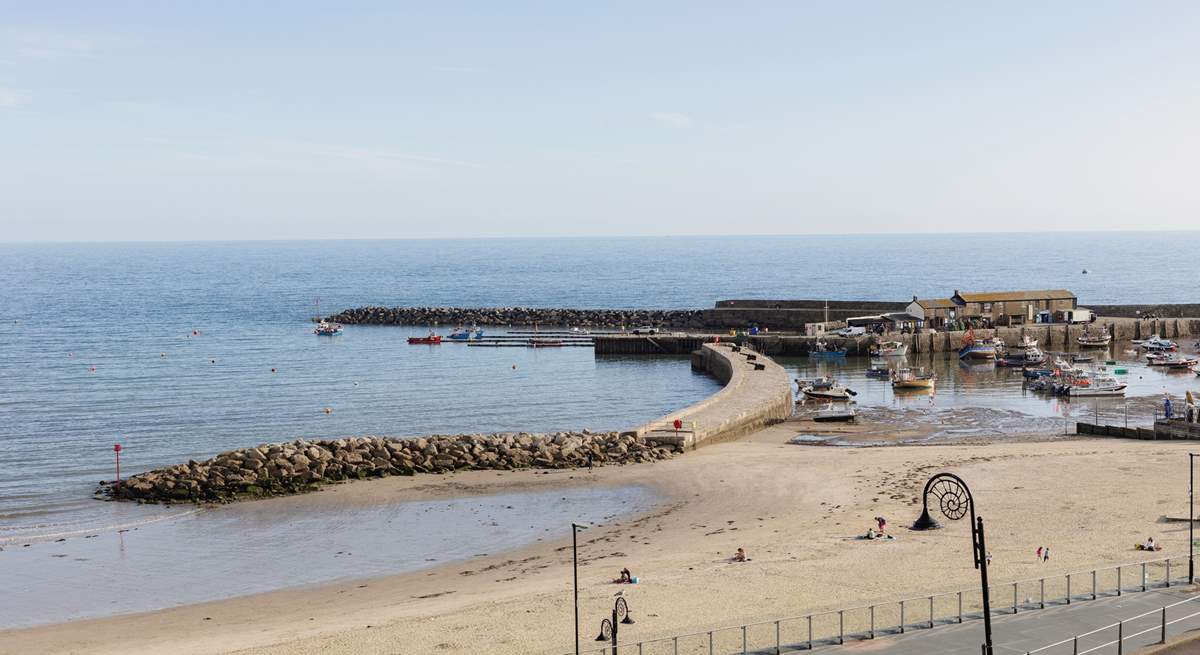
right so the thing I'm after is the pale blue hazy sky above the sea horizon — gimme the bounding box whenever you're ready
[0,0,1200,241]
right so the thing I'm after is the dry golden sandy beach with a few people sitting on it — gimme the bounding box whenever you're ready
[0,421,1189,654]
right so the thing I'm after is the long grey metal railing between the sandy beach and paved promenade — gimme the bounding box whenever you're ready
[568,557,1188,655]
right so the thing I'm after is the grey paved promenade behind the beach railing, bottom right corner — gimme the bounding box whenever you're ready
[859,589,1200,655]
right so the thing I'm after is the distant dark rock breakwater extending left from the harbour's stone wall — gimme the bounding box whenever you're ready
[326,307,704,329]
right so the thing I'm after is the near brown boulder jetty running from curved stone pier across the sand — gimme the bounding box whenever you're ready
[96,431,676,503]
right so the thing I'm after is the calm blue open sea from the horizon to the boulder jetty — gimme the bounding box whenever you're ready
[0,233,1200,539]
